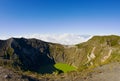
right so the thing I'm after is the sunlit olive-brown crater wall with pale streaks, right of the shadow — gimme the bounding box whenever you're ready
[52,35,120,68]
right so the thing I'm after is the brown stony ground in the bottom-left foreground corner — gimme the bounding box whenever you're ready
[0,66,39,81]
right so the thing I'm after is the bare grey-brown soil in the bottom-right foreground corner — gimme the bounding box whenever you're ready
[79,63,120,81]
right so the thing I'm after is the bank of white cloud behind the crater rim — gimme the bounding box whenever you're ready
[0,34,92,45]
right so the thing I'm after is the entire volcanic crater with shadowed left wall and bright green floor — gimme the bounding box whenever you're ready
[0,35,120,81]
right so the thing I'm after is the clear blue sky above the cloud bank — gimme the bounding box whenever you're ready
[0,0,120,36]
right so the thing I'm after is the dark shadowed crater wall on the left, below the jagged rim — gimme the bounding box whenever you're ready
[0,38,55,70]
